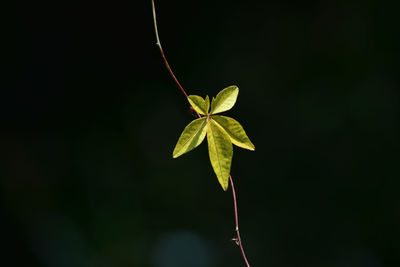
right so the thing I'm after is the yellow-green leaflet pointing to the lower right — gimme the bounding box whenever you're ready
[212,115,255,150]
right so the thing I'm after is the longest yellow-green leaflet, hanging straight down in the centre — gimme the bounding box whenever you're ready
[207,119,233,191]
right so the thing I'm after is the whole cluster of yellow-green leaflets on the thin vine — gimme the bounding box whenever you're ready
[172,86,255,191]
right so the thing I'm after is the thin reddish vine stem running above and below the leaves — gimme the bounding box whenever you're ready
[151,0,250,267]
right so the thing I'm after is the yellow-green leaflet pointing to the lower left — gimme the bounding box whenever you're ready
[172,117,208,158]
